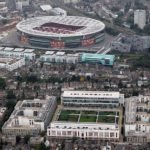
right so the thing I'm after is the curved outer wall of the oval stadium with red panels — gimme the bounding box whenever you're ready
[18,30,105,48]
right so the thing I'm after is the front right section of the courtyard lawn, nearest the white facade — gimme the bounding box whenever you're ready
[98,116,115,123]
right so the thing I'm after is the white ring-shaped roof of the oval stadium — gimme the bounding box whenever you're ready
[16,16,105,37]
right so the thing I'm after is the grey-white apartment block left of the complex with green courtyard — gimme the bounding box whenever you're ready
[2,97,57,136]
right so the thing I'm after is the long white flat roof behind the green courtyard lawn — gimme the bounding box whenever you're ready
[62,91,120,98]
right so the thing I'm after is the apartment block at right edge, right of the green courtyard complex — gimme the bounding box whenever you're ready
[125,95,150,143]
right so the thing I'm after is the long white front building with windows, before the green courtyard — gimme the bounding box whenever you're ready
[47,122,120,140]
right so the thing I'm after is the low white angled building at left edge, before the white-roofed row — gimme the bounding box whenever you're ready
[0,57,25,71]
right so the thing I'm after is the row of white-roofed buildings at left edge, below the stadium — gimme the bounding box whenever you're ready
[0,47,36,60]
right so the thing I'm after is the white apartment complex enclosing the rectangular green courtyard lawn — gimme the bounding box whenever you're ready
[47,91,124,141]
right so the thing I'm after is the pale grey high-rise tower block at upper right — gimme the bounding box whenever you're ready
[134,10,146,29]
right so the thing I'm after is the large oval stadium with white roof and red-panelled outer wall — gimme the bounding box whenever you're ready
[16,16,105,48]
